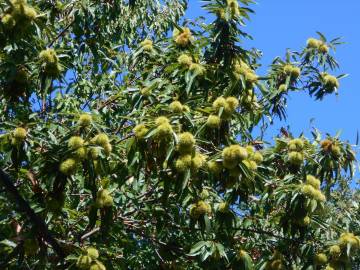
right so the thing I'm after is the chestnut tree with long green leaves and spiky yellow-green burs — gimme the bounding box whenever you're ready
[0,0,360,270]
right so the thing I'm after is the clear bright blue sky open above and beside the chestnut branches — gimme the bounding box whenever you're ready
[186,0,360,148]
